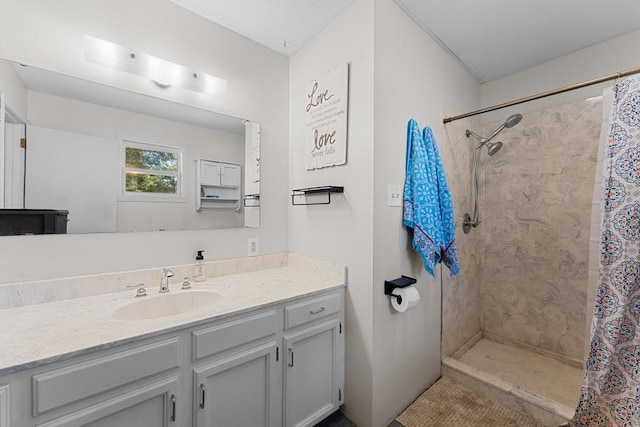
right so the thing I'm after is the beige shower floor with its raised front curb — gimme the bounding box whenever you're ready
[442,338,583,427]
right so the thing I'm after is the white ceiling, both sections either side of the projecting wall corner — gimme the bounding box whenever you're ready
[171,0,640,82]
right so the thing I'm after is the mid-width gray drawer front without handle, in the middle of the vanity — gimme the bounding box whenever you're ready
[191,310,276,362]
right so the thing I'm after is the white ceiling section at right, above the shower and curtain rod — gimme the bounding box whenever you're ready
[396,0,640,82]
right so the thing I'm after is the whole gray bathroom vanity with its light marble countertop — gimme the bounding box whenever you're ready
[0,254,345,427]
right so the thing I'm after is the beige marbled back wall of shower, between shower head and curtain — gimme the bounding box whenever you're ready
[482,98,602,360]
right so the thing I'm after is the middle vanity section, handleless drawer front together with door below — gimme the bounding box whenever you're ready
[192,308,282,427]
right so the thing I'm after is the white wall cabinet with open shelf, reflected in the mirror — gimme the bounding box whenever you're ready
[196,159,242,211]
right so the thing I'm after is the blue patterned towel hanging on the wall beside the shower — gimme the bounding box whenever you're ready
[403,119,460,276]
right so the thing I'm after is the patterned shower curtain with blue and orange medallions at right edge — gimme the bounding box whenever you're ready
[569,75,640,427]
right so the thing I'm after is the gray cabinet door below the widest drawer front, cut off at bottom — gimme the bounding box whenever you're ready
[37,377,179,427]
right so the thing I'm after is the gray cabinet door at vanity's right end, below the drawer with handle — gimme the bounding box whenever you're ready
[284,319,343,427]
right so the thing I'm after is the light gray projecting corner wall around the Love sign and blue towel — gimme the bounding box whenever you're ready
[289,0,479,427]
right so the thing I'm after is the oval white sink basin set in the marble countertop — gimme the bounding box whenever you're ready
[112,290,220,320]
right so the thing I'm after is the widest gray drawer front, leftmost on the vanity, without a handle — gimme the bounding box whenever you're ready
[32,338,178,416]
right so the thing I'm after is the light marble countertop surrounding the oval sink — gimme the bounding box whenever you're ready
[0,266,345,375]
